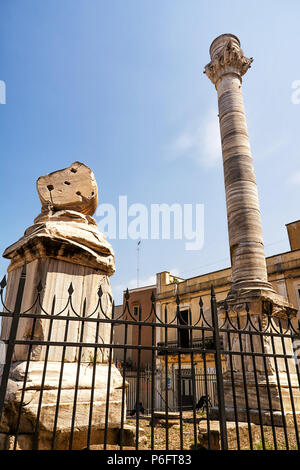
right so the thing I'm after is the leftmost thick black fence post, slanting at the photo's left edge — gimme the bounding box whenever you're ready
[0,263,26,423]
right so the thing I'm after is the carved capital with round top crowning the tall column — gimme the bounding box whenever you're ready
[204,34,253,84]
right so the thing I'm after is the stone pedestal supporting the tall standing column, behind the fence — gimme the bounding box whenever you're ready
[219,291,300,426]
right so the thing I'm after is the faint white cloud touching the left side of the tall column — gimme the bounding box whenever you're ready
[168,109,222,168]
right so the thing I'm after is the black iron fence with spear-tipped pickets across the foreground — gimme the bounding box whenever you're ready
[0,266,300,450]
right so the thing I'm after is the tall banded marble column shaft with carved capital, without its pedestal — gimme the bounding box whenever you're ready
[205,34,272,300]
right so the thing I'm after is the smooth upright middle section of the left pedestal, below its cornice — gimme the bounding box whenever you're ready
[0,258,112,362]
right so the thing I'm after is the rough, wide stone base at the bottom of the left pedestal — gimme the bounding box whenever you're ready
[0,361,126,449]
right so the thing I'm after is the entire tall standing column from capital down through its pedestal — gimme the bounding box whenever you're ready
[204,34,300,422]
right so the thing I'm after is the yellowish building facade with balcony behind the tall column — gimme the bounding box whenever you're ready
[156,221,300,409]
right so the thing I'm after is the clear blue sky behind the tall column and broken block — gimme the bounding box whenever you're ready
[0,0,300,302]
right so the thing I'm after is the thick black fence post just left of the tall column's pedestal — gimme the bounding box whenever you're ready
[211,286,228,450]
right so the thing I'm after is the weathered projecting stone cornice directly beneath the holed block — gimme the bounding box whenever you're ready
[3,210,115,276]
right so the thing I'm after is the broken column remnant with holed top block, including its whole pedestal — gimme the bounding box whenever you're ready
[0,162,125,449]
